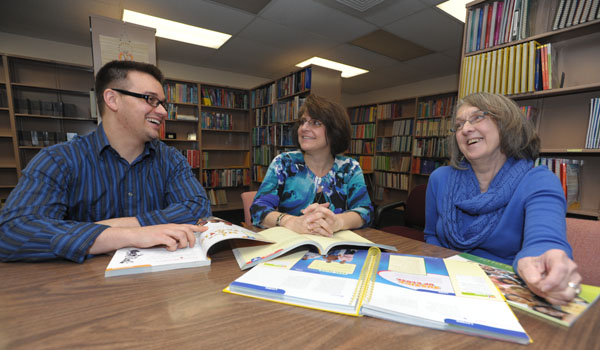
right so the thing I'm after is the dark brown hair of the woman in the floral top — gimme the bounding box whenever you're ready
[292,94,352,157]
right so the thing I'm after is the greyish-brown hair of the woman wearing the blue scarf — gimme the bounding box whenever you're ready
[448,92,540,169]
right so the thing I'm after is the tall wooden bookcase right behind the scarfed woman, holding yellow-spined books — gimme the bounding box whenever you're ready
[459,0,600,219]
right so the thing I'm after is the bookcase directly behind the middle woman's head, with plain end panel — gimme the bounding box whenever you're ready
[250,66,341,183]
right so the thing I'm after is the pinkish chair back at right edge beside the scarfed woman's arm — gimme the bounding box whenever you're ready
[567,218,600,286]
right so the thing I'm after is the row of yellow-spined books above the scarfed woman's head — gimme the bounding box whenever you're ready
[459,40,553,97]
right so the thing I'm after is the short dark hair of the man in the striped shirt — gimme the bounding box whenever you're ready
[95,61,164,114]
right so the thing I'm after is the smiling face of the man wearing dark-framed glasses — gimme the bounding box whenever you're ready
[118,71,167,142]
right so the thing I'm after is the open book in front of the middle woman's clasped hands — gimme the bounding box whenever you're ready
[233,227,397,270]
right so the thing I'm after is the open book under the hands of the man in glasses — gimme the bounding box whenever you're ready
[104,217,272,277]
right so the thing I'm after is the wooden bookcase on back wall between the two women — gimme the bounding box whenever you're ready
[373,91,457,204]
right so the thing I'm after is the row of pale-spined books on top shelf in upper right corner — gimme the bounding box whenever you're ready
[552,0,600,30]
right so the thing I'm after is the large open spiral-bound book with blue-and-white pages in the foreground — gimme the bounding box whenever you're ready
[224,247,530,344]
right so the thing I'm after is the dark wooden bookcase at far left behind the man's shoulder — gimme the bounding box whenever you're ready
[0,55,97,205]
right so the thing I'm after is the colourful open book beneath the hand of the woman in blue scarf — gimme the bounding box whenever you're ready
[450,253,600,327]
